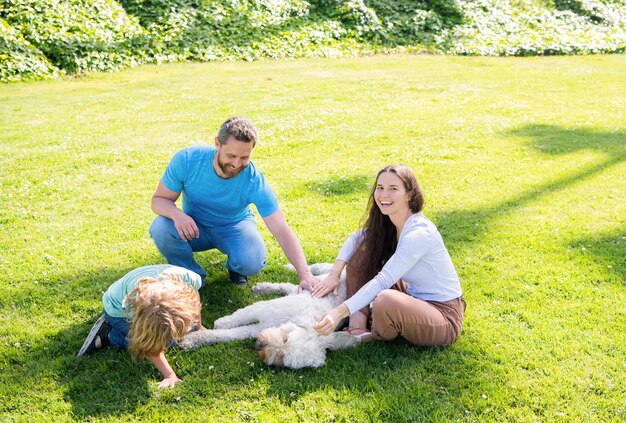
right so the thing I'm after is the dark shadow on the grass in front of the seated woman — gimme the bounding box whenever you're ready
[254,339,488,421]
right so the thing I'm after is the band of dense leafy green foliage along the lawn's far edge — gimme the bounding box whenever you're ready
[0,0,626,81]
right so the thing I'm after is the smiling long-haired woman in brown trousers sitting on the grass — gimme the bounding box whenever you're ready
[313,165,465,345]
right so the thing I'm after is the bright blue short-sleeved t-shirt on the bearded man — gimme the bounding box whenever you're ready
[161,145,279,228]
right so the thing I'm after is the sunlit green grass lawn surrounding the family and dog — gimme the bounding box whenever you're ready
[0,55,626,422]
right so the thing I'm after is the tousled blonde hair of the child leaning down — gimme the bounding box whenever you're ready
[126,274,201,358]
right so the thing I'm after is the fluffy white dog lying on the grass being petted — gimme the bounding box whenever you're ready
[179,263,360,369]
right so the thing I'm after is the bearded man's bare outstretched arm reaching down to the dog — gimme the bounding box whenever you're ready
[263,210,318,291]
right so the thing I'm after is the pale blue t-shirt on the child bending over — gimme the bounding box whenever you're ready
[102,264,202,317]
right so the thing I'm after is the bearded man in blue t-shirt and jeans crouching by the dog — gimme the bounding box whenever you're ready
[150,117,317,290]
